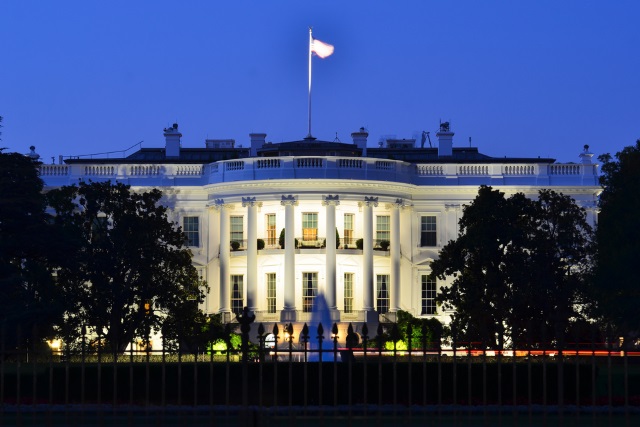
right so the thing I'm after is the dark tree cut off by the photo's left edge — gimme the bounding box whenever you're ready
[0,150,61,352]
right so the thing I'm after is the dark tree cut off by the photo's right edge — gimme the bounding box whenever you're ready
[594,140,640,342]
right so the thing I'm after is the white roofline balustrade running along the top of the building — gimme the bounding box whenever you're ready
[40,156,598,186]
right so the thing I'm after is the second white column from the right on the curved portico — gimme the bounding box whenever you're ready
[360,197,378,322]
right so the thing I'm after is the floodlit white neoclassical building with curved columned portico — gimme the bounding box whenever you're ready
[41,123,600,337]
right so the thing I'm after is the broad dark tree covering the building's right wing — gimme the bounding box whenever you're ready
[431,186,592,348]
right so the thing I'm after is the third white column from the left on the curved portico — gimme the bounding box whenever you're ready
[280,196,298,322]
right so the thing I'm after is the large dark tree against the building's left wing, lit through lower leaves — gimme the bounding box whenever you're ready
[48,182,206,352]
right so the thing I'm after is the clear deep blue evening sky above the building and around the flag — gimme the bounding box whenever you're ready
[0,0,640,163]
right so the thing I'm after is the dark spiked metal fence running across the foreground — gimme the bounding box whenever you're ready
[0,320,640,417]
